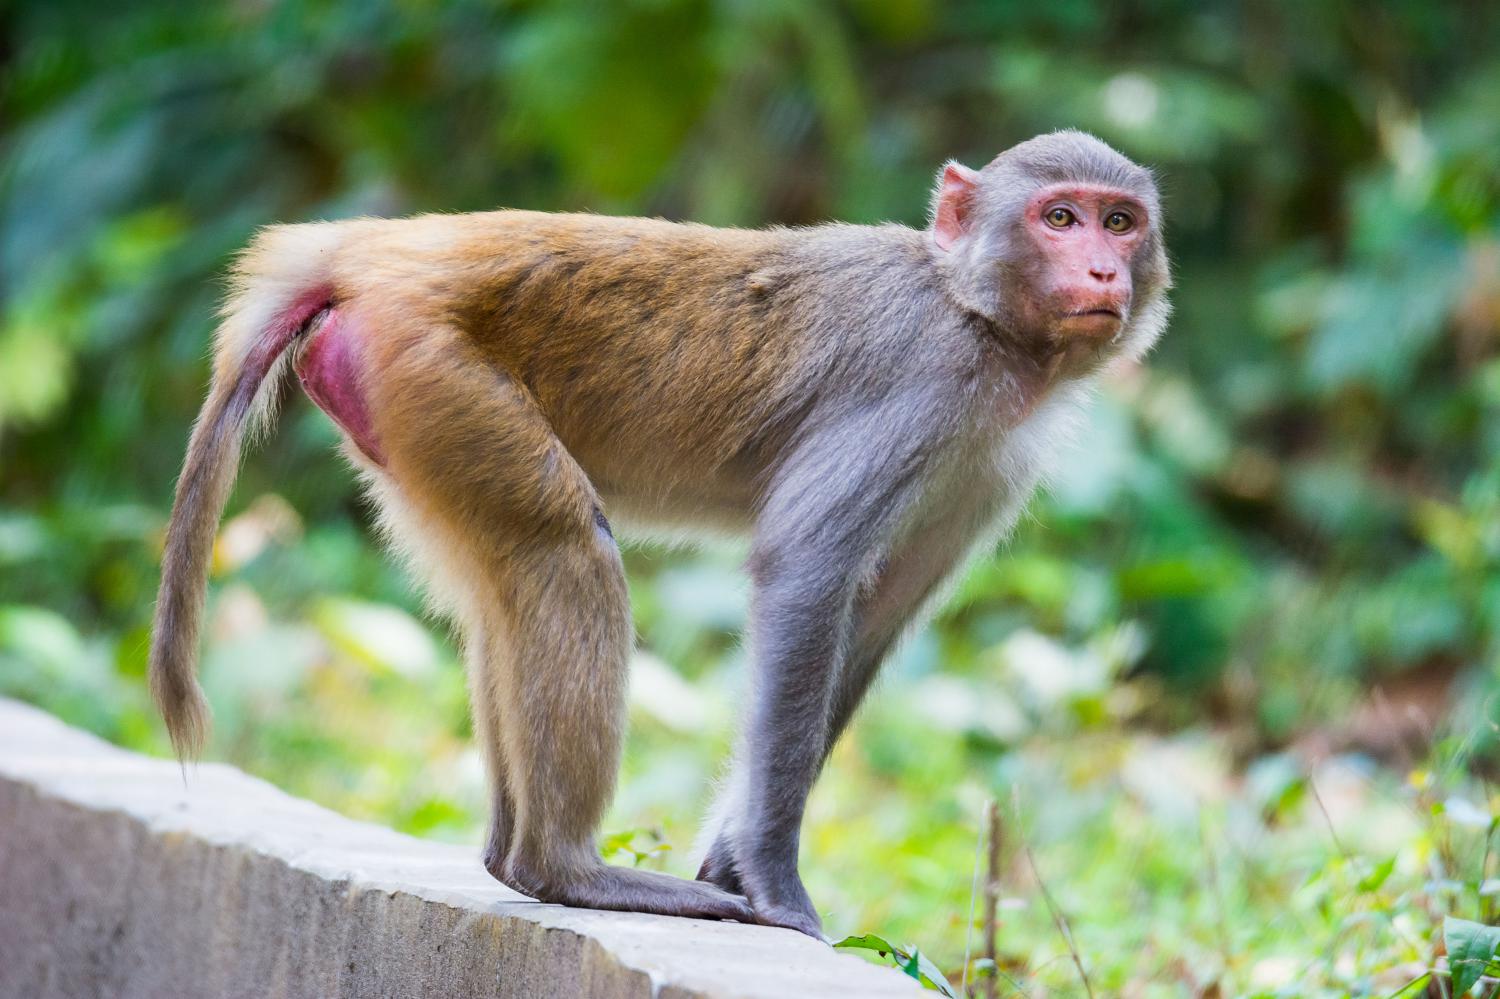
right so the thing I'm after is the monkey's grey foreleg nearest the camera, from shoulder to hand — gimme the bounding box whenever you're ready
[699,392,954,938]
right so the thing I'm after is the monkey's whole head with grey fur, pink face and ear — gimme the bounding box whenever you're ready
[932,132,1172,364]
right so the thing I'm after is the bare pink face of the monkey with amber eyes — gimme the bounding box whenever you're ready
[1025,183,1148,336]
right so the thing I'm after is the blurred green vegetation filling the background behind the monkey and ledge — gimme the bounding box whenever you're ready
[0,0,1500,996]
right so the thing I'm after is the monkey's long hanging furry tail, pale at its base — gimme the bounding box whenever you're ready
[150,224,343,759]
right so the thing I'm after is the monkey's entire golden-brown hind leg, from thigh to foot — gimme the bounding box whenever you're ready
[384,342,753,921]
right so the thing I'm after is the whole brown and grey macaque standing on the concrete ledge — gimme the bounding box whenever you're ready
[150,132,1170,936]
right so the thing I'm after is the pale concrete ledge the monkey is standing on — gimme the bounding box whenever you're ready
[0,699,921,999]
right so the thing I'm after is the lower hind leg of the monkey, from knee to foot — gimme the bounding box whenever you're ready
[474,567,753,921]
